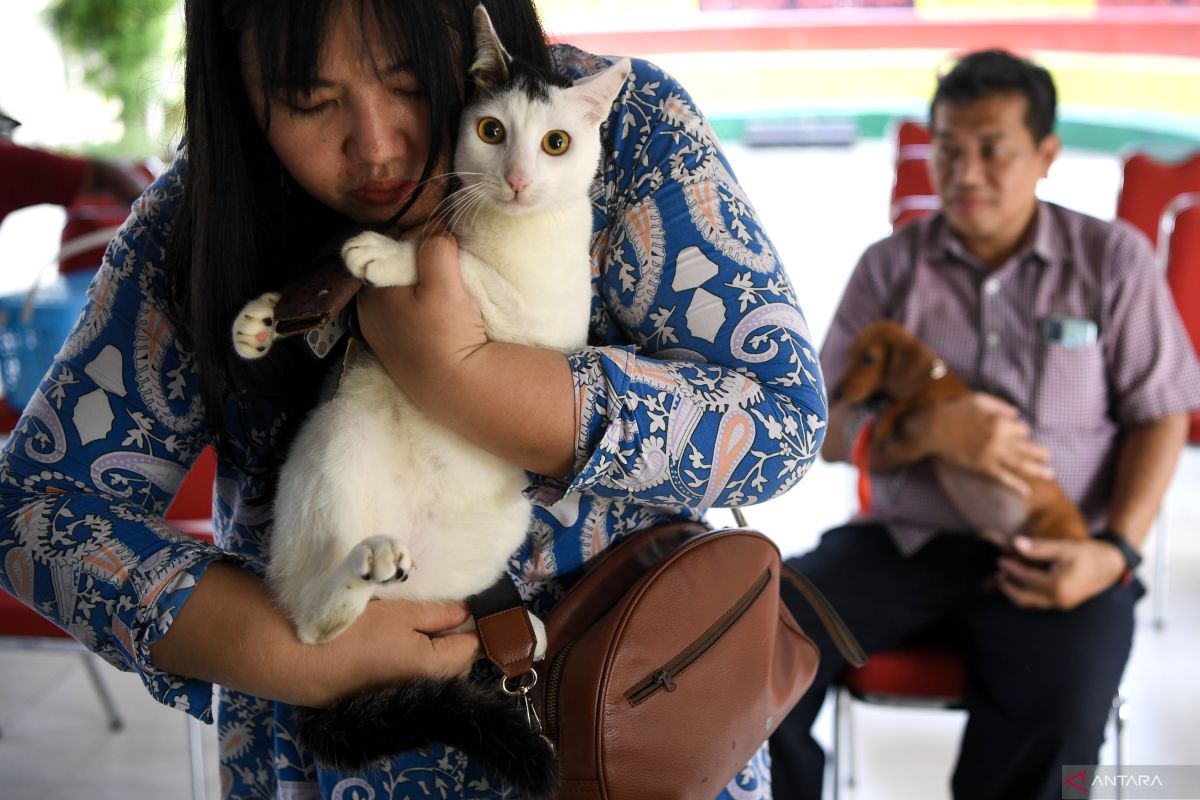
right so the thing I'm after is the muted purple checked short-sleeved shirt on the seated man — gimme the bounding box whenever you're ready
[821,203,1200,553]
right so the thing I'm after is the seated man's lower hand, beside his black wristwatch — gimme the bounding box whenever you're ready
[997,536,1126,610]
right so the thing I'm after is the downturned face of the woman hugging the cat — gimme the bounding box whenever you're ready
[242,2,445,227]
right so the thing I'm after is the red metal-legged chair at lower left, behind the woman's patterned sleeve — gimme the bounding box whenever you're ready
[0,447,216,800]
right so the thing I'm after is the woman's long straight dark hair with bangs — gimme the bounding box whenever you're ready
[167,0,550,469]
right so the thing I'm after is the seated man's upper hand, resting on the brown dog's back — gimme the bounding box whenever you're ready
[906,392,1054,497]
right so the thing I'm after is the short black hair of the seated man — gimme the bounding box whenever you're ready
[929,50,1057,144]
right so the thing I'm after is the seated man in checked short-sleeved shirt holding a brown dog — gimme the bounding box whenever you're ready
[770,50,1200,800]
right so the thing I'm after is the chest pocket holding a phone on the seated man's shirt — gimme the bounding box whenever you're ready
[1033,343,1109,429]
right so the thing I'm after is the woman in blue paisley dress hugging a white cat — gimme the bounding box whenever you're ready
[0,0,826,798]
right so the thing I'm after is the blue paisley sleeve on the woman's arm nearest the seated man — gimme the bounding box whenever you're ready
[549,60,827,509]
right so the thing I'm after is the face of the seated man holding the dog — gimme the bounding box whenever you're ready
[930,92,1061,266]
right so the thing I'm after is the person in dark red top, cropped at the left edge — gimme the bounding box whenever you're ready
[0,106,148,222]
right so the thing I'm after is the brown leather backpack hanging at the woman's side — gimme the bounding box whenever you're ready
[476,523,865,800]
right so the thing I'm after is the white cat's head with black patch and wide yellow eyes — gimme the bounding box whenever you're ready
[455,5,630,213]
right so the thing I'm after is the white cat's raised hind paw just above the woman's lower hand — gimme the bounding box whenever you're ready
[295,535,415,644]
